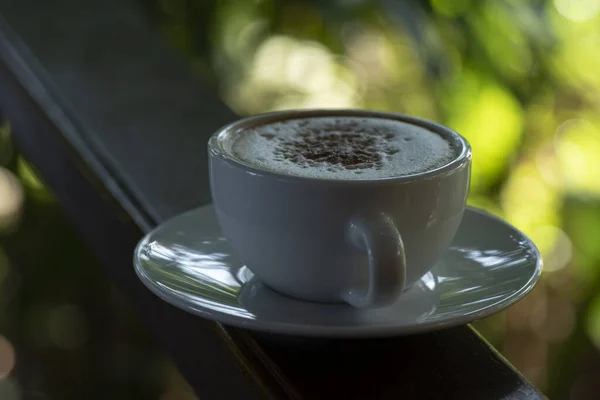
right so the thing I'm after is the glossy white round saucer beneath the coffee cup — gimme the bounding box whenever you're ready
[134,205,542,337]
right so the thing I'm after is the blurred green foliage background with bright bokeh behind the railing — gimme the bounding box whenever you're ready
[0,0,600,399]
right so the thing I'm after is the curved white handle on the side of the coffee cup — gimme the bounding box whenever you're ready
[343,213,406,308]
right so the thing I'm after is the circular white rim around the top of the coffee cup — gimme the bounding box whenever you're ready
[208,109,471,185]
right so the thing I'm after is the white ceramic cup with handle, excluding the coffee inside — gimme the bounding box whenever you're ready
[208,110,471,307]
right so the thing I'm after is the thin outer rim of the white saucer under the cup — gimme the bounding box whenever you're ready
[133,204,543,338]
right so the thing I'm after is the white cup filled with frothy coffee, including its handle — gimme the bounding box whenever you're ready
[208,110,471,307]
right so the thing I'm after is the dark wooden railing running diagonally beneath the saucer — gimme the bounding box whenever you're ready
[0,0,543,399]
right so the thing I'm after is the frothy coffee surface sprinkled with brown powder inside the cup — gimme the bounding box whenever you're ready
[231,117,455,180]
